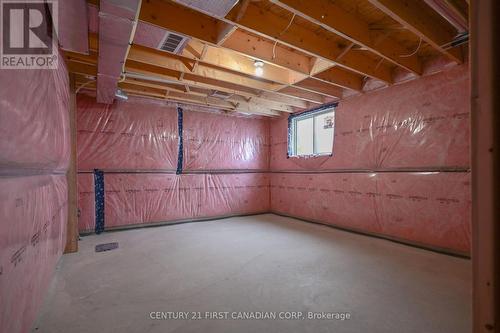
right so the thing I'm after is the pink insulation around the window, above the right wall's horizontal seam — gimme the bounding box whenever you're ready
[271,65,470,170]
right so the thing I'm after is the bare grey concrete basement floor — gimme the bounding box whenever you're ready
[33,214,471,333]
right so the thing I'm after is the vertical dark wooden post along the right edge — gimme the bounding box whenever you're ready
[470,0,500,333]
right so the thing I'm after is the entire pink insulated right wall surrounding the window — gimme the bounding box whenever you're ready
[270,65,471,254]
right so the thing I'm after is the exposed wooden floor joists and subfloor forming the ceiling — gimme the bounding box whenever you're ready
[65,0,467,116]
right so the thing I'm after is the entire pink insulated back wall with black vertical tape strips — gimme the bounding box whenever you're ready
[77,95,270,232]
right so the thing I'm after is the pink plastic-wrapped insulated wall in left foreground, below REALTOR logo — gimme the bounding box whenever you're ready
[0,56,70,333]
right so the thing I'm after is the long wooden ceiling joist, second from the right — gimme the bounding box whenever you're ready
[271,0,422,75]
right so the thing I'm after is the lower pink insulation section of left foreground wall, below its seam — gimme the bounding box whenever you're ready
[0,175,68,332]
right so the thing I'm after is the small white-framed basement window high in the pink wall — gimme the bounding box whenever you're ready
[288,104,337,157]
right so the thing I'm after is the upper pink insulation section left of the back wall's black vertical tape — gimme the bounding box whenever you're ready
[77,94,179,171]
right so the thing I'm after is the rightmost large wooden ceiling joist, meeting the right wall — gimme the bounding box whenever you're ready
[369,0,463,63]
